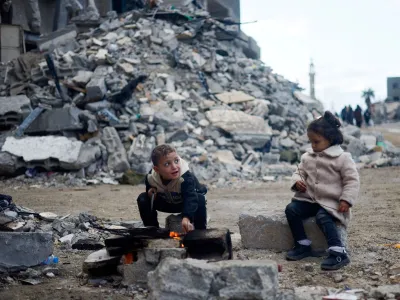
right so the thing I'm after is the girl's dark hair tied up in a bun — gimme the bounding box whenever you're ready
[307,111,343,146]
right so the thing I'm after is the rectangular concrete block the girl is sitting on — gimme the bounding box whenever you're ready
[239,214,347,251]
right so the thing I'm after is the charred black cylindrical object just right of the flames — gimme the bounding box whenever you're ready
[182,229,233,260]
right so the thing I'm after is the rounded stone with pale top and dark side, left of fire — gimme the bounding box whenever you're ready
[83,249,121,276]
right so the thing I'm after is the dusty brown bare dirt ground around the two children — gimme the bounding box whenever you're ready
[0,168,400,299]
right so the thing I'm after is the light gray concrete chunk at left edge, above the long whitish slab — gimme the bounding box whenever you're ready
[0,95,32,126]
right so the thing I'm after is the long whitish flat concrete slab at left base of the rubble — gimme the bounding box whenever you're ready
[2,136,83,164]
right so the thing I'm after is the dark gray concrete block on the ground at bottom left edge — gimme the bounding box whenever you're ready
[0,232,53,272]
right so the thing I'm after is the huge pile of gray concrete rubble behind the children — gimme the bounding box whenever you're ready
[0,4,397,185]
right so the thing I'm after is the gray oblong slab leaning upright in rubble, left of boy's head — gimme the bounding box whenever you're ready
[101,127,130,173]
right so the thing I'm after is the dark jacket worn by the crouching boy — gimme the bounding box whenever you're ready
[145,159,207,221]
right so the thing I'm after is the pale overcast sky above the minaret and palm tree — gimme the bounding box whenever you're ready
[241,0,400,111]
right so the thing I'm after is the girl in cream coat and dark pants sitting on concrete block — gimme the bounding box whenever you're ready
[285,111,360,270]
